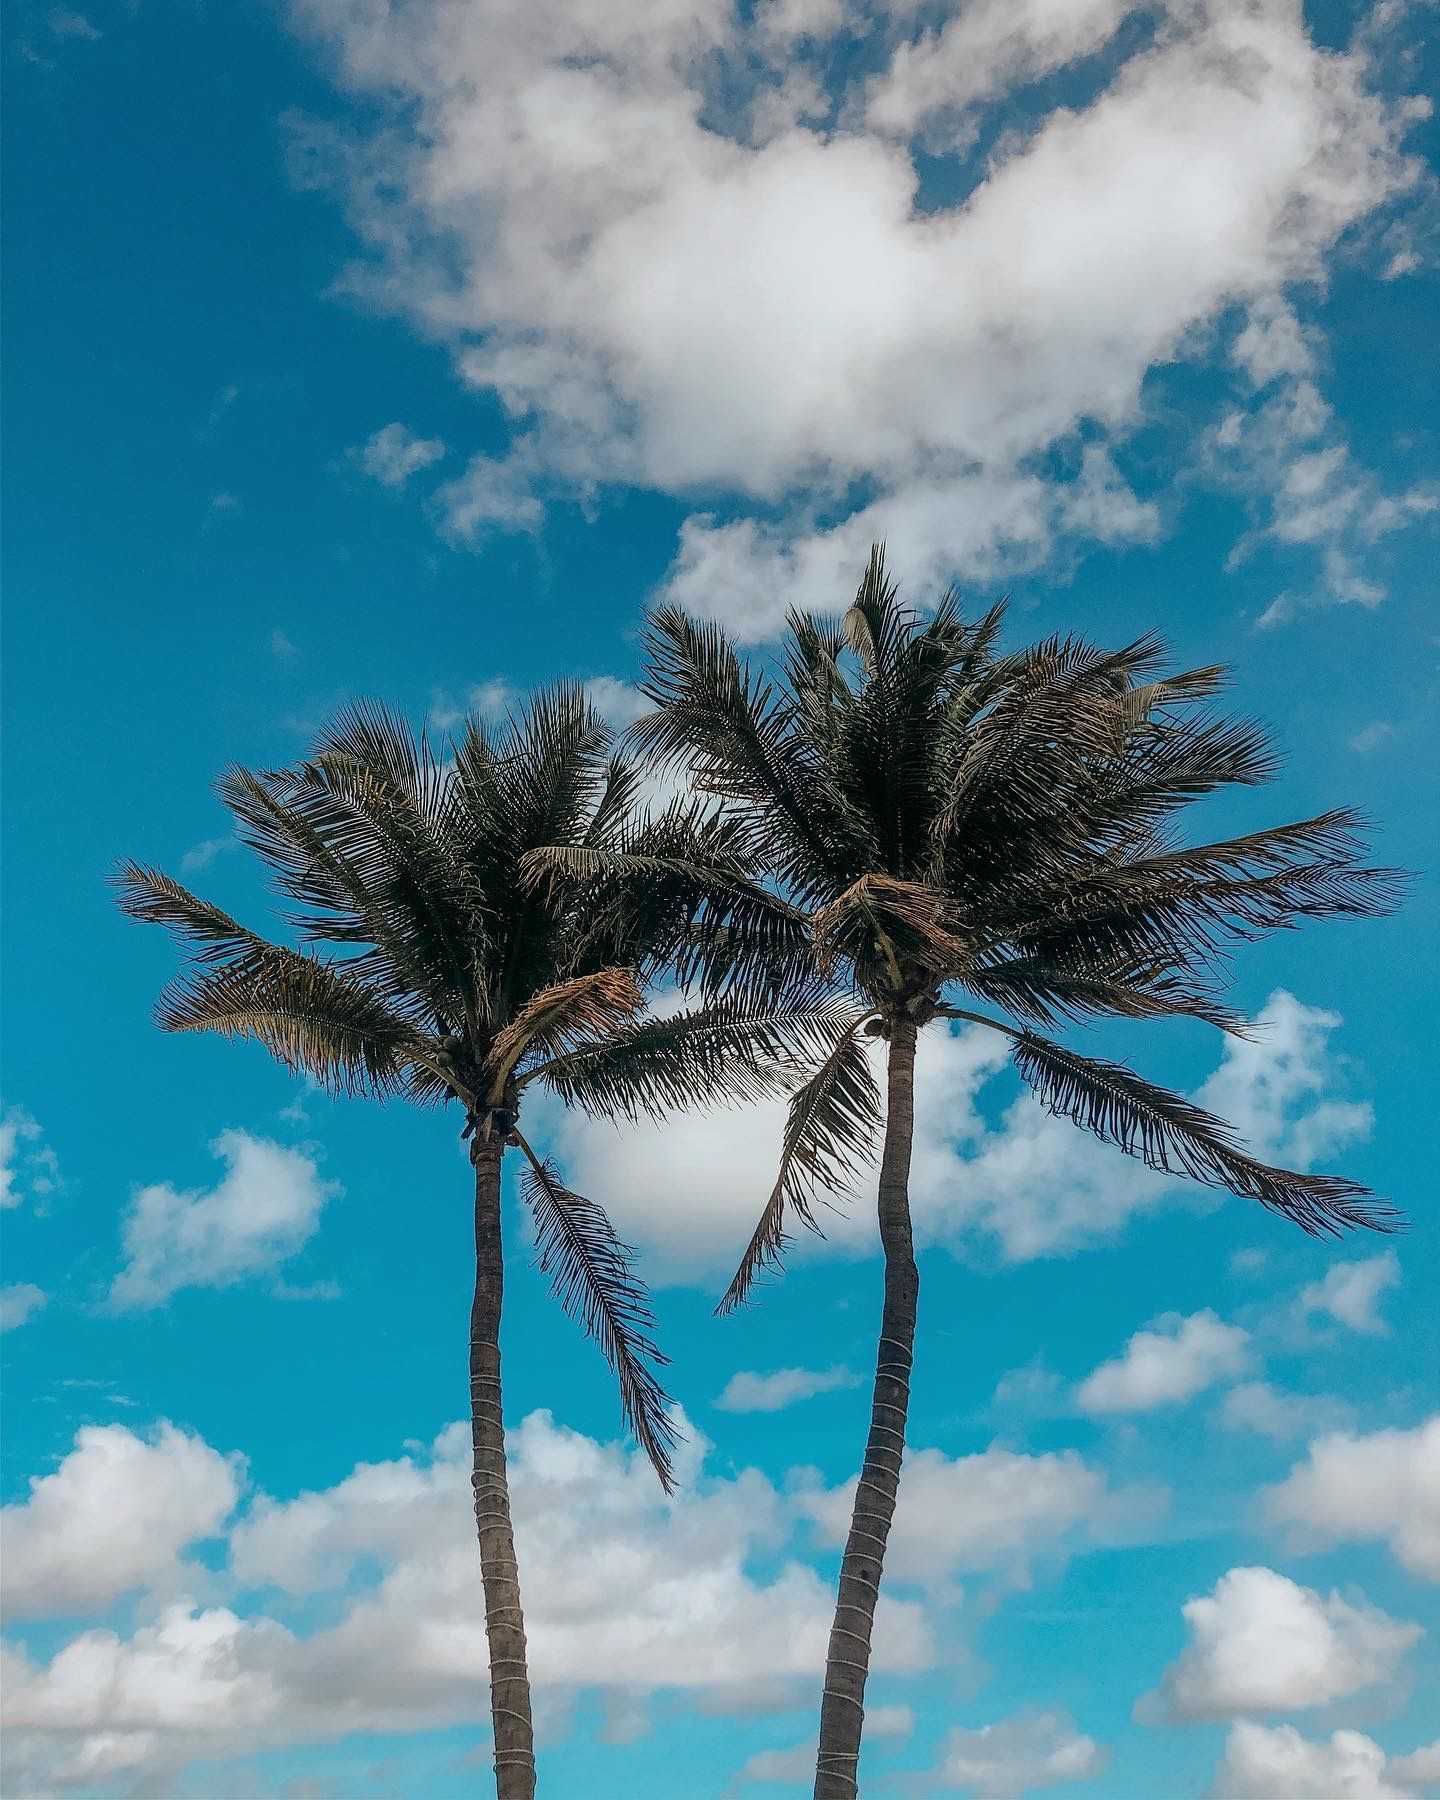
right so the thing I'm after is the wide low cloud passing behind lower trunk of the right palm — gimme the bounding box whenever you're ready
[797,1445,1157,1582]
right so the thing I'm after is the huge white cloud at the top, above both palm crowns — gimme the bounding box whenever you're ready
[286,0,1413,635]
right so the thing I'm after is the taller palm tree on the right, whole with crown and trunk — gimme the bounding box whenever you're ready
[634,549,1397,1800]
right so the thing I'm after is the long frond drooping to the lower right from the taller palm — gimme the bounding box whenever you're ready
[1013,1031,1400,1237]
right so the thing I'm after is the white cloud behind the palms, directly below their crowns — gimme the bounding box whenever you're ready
[553,990,1372,1283]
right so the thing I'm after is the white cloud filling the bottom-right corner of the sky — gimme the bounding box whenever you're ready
[1210,1721,1440,1800]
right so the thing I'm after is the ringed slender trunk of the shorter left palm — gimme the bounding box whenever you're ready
[470,1132,535,1800]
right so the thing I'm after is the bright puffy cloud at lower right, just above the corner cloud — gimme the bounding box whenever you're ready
[1138,1568,1424,1723]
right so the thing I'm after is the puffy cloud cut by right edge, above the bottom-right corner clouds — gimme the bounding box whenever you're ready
[1265,1413,1440,1580]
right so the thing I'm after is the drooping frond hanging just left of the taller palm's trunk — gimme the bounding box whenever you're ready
[715,1013,884,1312]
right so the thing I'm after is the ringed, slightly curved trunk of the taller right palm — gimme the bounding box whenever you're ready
[815,1017,920,1800]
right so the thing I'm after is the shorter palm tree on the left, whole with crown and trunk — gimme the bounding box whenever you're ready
[117,688,833,1800]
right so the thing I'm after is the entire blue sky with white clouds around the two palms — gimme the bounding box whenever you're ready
[4,0,1440,1800]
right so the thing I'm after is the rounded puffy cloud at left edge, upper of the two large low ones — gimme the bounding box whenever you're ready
[0,1422,239,1618]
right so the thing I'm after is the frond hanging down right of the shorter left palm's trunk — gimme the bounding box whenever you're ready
[517,1134,679,1494]
